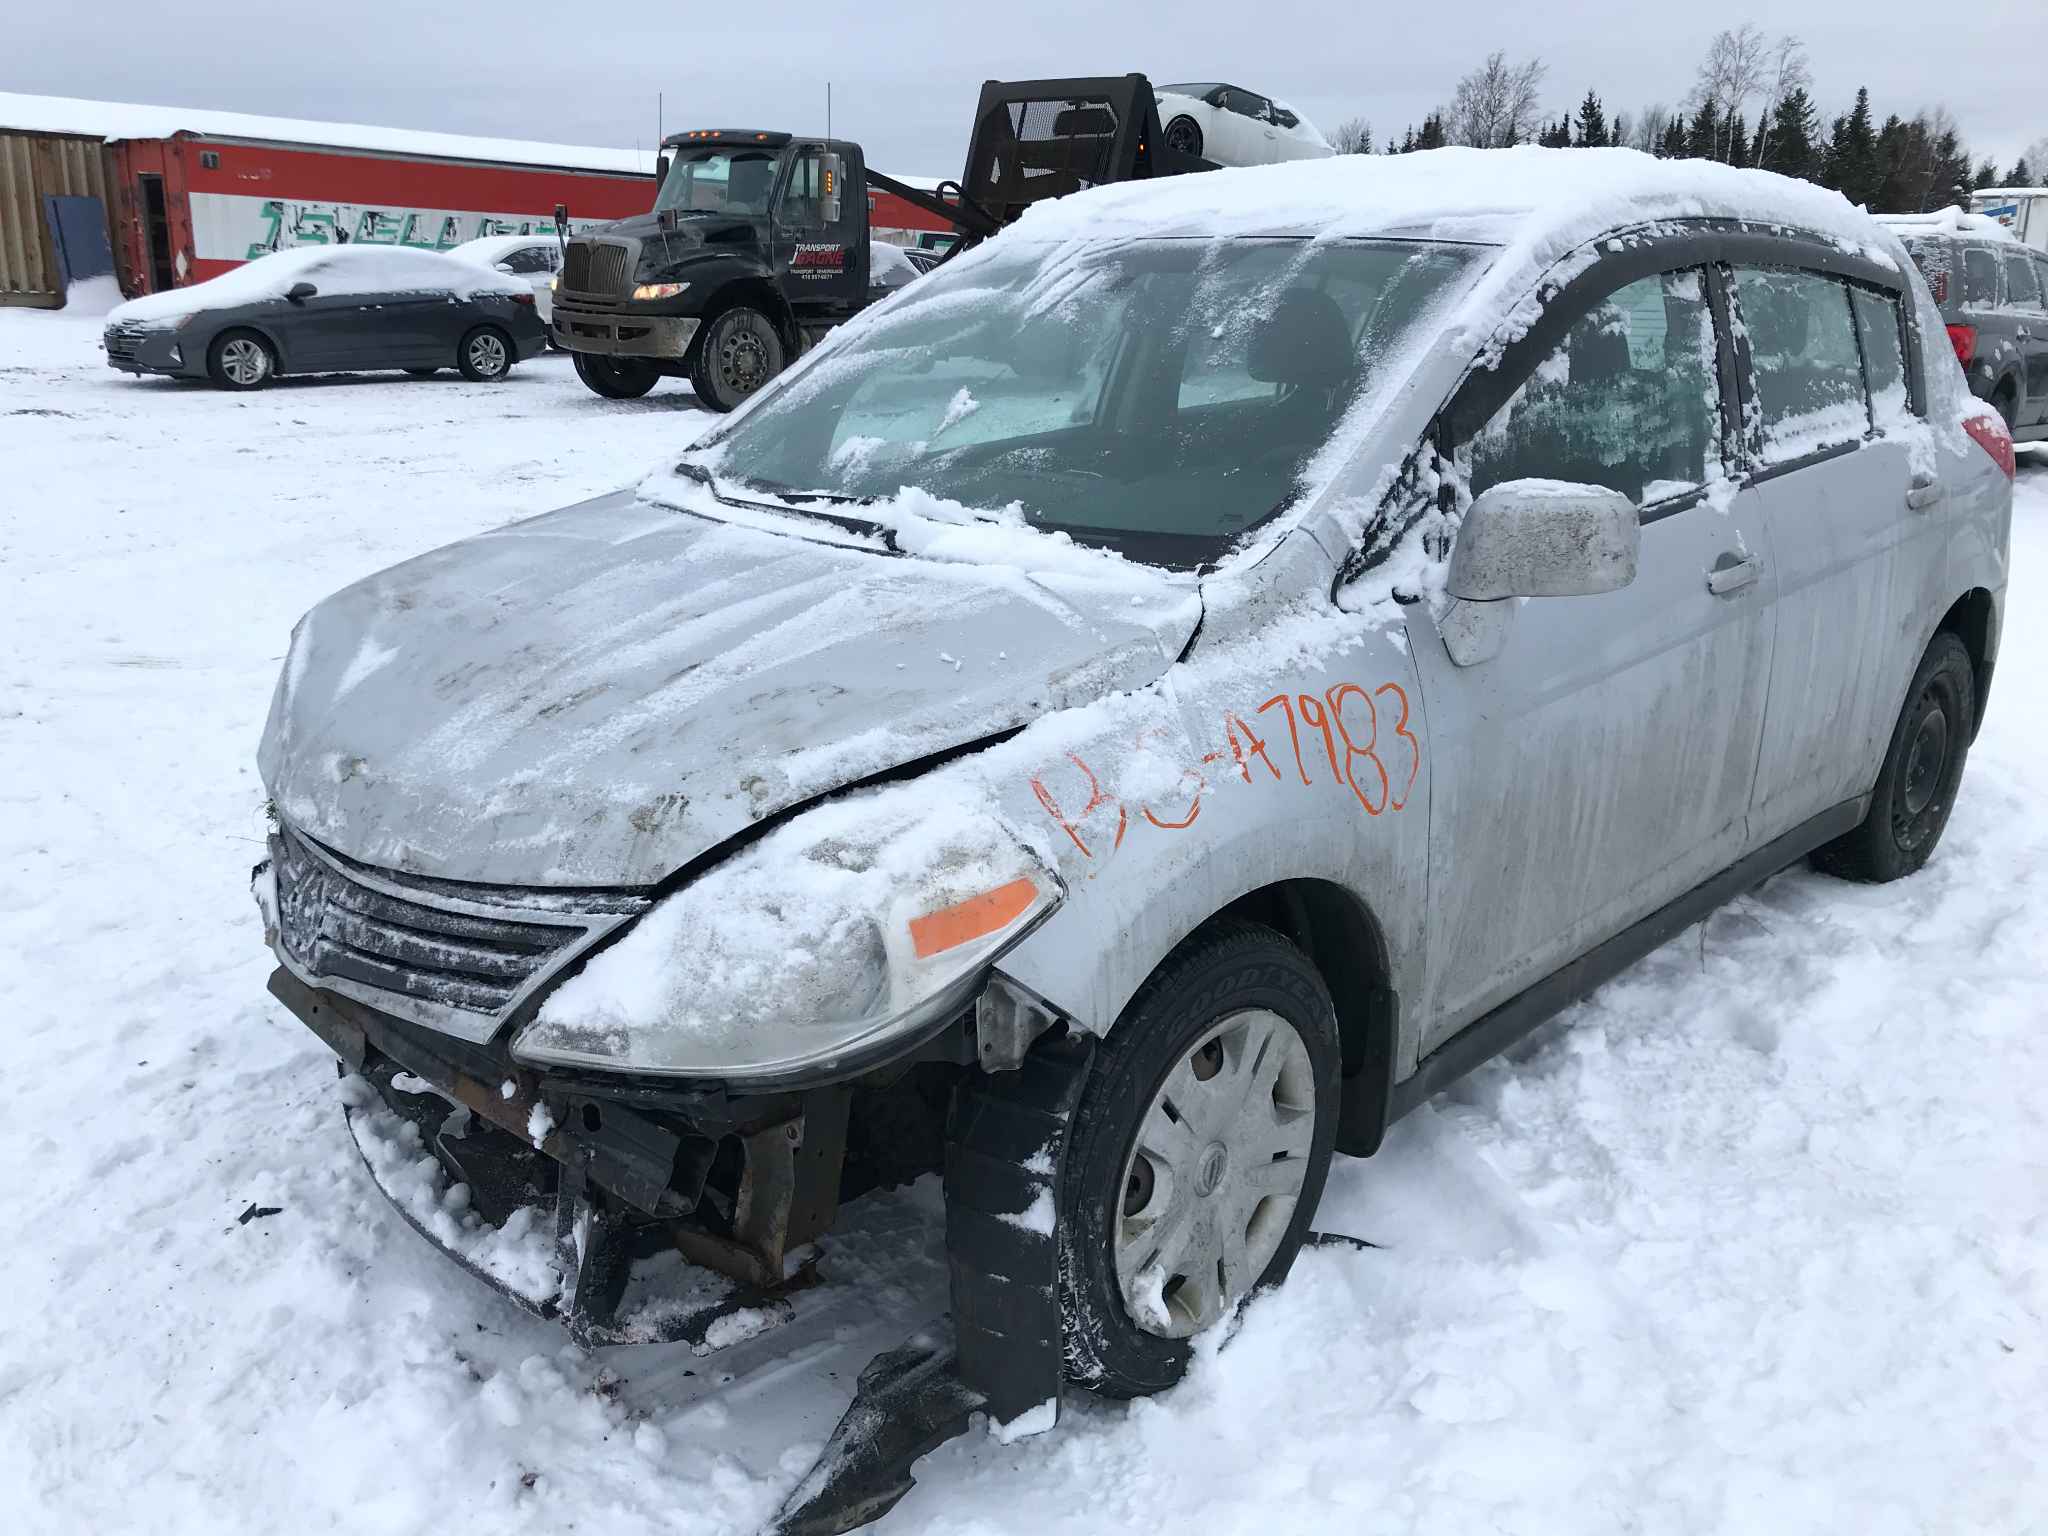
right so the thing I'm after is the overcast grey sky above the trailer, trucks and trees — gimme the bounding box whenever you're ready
[0,0,2048,176]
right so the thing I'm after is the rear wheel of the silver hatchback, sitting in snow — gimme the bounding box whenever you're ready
[1812,631,1976,883]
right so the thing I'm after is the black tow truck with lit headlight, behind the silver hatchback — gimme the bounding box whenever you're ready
[553,74,1210,412]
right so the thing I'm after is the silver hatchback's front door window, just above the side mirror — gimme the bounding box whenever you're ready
[1466,268,1720,508]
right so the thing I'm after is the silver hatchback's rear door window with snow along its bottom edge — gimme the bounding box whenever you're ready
[1735,266,1870,465]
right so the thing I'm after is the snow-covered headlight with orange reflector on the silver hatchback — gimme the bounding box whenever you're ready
[512,797,1061,1083]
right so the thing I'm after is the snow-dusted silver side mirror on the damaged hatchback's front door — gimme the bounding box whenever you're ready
[1444,479,1642,602]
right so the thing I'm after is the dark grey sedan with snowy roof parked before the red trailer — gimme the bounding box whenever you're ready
[102,246,547,389]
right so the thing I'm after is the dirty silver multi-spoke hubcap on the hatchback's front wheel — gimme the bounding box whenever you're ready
[1112,1010,1315,1339]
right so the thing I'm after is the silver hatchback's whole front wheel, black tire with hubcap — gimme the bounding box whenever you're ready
[1059,922,1339,1397]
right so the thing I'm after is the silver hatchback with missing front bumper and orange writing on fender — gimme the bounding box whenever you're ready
[256,150,2013,1482]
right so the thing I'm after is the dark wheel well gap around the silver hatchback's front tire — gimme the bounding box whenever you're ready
[1217,879,1399,1157]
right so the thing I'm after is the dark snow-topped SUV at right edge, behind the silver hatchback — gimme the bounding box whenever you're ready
[1878,209,2048,442]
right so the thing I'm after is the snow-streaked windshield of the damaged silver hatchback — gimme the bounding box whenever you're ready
[698,240,1485,567]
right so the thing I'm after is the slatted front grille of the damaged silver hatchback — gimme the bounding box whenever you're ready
[270,829,649,1034]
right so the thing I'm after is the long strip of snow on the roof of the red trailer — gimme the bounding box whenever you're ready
[0,90,653,176]
